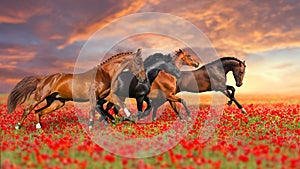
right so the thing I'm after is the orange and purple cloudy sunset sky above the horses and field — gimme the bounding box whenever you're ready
[0,0,300,94]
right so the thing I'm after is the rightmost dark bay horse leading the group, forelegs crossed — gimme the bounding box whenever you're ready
[151,57,247,120]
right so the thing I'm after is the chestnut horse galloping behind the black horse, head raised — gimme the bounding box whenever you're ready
[99,49,199,119]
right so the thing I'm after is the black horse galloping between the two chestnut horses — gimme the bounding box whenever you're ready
[96,53,181,124]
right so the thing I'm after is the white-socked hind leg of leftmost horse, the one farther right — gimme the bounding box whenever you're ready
[35,99,65,129]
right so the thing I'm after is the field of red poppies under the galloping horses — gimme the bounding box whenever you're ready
[0,95,300,169]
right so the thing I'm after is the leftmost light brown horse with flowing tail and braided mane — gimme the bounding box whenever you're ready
[7,49,147,129]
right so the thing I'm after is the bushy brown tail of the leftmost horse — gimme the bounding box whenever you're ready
[7,76,39,113]
